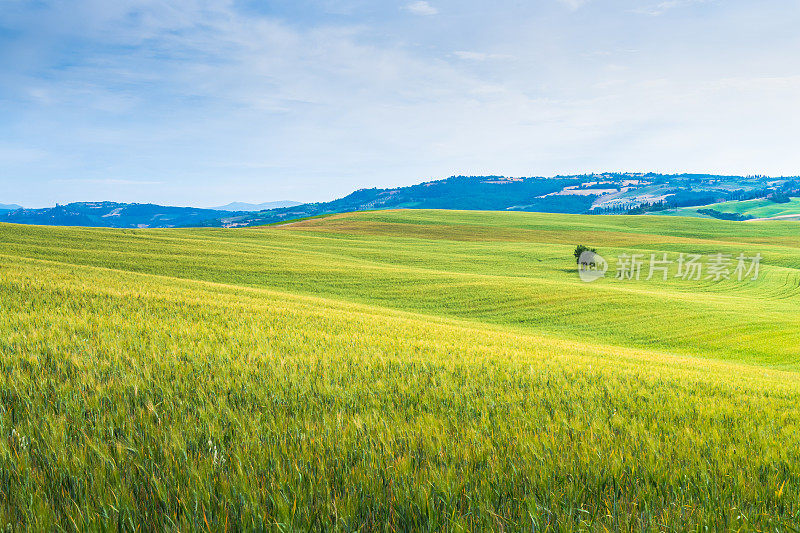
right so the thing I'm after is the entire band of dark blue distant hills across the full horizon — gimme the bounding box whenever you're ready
[0,172,800,228]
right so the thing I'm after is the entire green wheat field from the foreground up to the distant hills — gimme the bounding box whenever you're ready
[0,211,800,532]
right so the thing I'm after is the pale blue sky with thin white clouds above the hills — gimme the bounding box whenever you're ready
[0,0,800,207]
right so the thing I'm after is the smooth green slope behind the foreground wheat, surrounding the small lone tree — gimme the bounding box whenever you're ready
[0,211,800,368]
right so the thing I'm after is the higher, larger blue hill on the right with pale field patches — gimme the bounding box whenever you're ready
[205,172,800,227]
